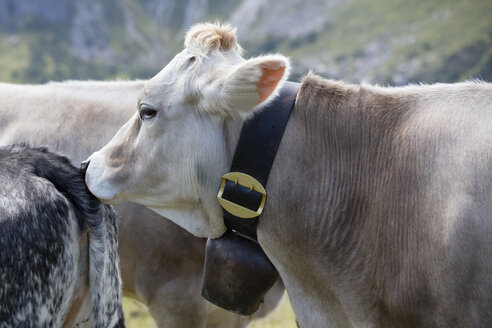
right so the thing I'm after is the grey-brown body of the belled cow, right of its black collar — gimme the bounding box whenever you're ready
[264,76,492,327]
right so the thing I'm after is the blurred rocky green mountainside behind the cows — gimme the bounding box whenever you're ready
[0,0,492,84]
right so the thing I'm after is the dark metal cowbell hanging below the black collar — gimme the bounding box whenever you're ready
[202,230,278,315]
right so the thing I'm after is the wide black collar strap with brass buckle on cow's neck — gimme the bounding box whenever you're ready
[217,82,300,240]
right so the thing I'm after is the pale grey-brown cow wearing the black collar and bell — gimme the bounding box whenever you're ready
[86,23,492,327]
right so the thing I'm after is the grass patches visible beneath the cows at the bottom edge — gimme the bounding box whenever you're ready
[123,297,296,328]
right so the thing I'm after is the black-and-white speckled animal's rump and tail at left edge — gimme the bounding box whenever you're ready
[0,145,124,328]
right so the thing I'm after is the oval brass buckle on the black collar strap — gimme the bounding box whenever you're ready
[217,172,266,219]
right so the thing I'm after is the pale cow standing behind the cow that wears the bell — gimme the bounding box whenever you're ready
[0,80,284,328]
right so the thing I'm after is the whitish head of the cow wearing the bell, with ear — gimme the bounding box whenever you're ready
[86,24,289,238]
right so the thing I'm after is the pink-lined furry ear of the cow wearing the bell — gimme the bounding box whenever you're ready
[224,55,290,115]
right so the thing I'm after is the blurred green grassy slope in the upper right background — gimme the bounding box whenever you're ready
[280,0,492,82]
